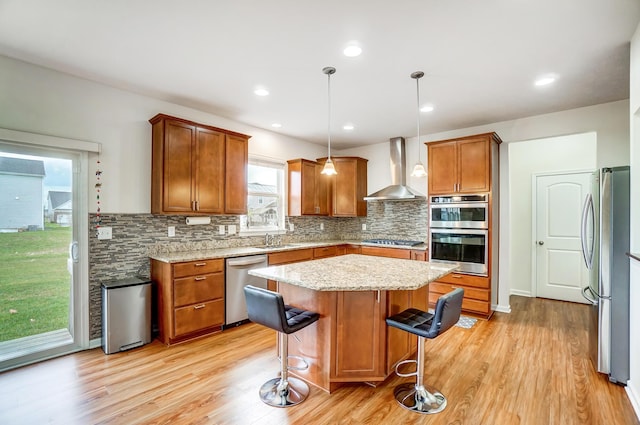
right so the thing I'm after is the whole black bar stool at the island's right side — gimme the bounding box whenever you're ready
[387,288,464,413]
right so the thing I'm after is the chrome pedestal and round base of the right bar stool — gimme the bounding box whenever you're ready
[393,336,447,414]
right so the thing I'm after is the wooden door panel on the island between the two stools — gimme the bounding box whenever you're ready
[332,291,386,379]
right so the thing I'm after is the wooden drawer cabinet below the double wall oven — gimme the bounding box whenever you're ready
[429,273,491,318]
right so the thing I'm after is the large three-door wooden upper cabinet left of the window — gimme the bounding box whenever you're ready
[149,114,249,215]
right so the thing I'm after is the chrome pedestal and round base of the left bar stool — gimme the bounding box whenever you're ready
[260,332,309,407]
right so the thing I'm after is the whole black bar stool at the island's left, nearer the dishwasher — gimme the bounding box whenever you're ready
[244,285,320,407]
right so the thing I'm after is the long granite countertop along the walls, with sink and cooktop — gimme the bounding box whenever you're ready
[149,240,427,263]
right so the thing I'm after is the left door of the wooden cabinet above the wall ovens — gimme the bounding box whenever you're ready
[427,141,458,195]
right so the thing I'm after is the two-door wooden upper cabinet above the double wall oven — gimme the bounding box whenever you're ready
[427,133,502,195]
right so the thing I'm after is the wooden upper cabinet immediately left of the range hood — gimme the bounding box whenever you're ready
[318,156,367,217]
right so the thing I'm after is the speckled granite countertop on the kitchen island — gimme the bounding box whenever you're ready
[249,254,457,291]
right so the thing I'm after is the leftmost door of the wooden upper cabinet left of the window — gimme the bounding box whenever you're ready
[162,120,196,213]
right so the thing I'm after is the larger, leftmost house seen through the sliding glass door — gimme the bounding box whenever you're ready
[0,157,45,232]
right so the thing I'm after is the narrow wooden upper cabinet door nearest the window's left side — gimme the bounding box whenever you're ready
[224,135,249,214]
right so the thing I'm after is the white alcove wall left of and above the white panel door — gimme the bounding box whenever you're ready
[502,132,597,296]
